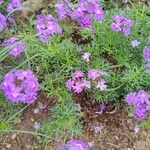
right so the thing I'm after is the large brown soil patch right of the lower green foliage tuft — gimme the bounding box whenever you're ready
[74,93,150,150]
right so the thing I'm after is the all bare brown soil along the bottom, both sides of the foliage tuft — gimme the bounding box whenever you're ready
[0,93,150,150]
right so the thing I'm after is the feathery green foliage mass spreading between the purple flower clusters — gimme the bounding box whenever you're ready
[0,0,150,141]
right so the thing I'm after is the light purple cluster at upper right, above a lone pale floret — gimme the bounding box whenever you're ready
[112,15,133,36]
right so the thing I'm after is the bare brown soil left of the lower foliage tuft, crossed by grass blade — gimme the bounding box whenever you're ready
[0,93,55,150]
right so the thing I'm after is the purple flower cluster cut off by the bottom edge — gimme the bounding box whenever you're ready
[67,140,88,150]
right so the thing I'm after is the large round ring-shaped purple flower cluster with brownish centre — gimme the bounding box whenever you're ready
[0,70,39,104]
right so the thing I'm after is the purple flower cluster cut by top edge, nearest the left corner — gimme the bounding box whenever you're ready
[7,0,23,12]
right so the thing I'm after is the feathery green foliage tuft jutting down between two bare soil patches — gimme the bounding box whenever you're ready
[41,100,82,139]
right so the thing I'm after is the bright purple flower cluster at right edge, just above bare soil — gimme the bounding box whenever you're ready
[125,90,150,120]
